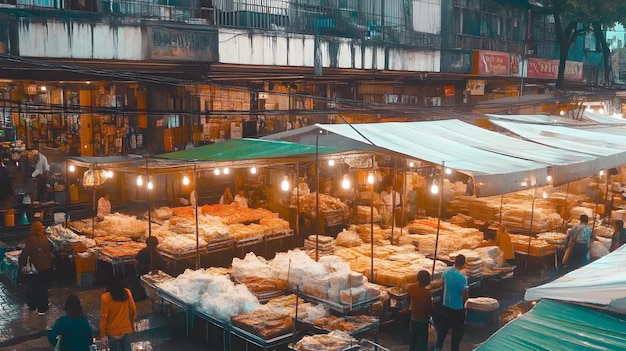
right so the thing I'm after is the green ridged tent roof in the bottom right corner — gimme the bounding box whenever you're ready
[475,300,626,351]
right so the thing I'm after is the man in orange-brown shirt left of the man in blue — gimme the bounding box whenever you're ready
[407,270,435,351]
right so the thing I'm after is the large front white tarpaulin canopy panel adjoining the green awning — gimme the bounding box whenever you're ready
[266,122,548,196]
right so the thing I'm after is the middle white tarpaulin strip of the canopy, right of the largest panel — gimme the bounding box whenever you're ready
[411,120,602,185]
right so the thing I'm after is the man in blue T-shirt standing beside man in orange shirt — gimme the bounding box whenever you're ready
[435,255,468,351]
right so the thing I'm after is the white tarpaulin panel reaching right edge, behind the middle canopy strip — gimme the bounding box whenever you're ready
[491,120,626,169]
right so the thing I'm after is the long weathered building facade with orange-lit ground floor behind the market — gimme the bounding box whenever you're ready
[0,0,602,156]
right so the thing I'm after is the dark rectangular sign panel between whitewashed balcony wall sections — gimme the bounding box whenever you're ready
[149,27,218,61]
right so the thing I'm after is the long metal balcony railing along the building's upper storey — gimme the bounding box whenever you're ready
[8,0,441,48]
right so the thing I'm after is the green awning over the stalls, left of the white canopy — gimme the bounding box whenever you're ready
[156,139,335,162]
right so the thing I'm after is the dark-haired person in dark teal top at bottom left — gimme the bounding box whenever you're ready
[48,295,93,351]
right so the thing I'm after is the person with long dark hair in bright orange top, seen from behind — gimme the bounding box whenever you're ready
[100,278,137,351]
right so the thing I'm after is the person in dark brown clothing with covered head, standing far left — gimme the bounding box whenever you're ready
[18,212,52,316]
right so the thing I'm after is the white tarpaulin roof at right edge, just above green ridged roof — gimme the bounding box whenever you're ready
[524,245,626,313]
